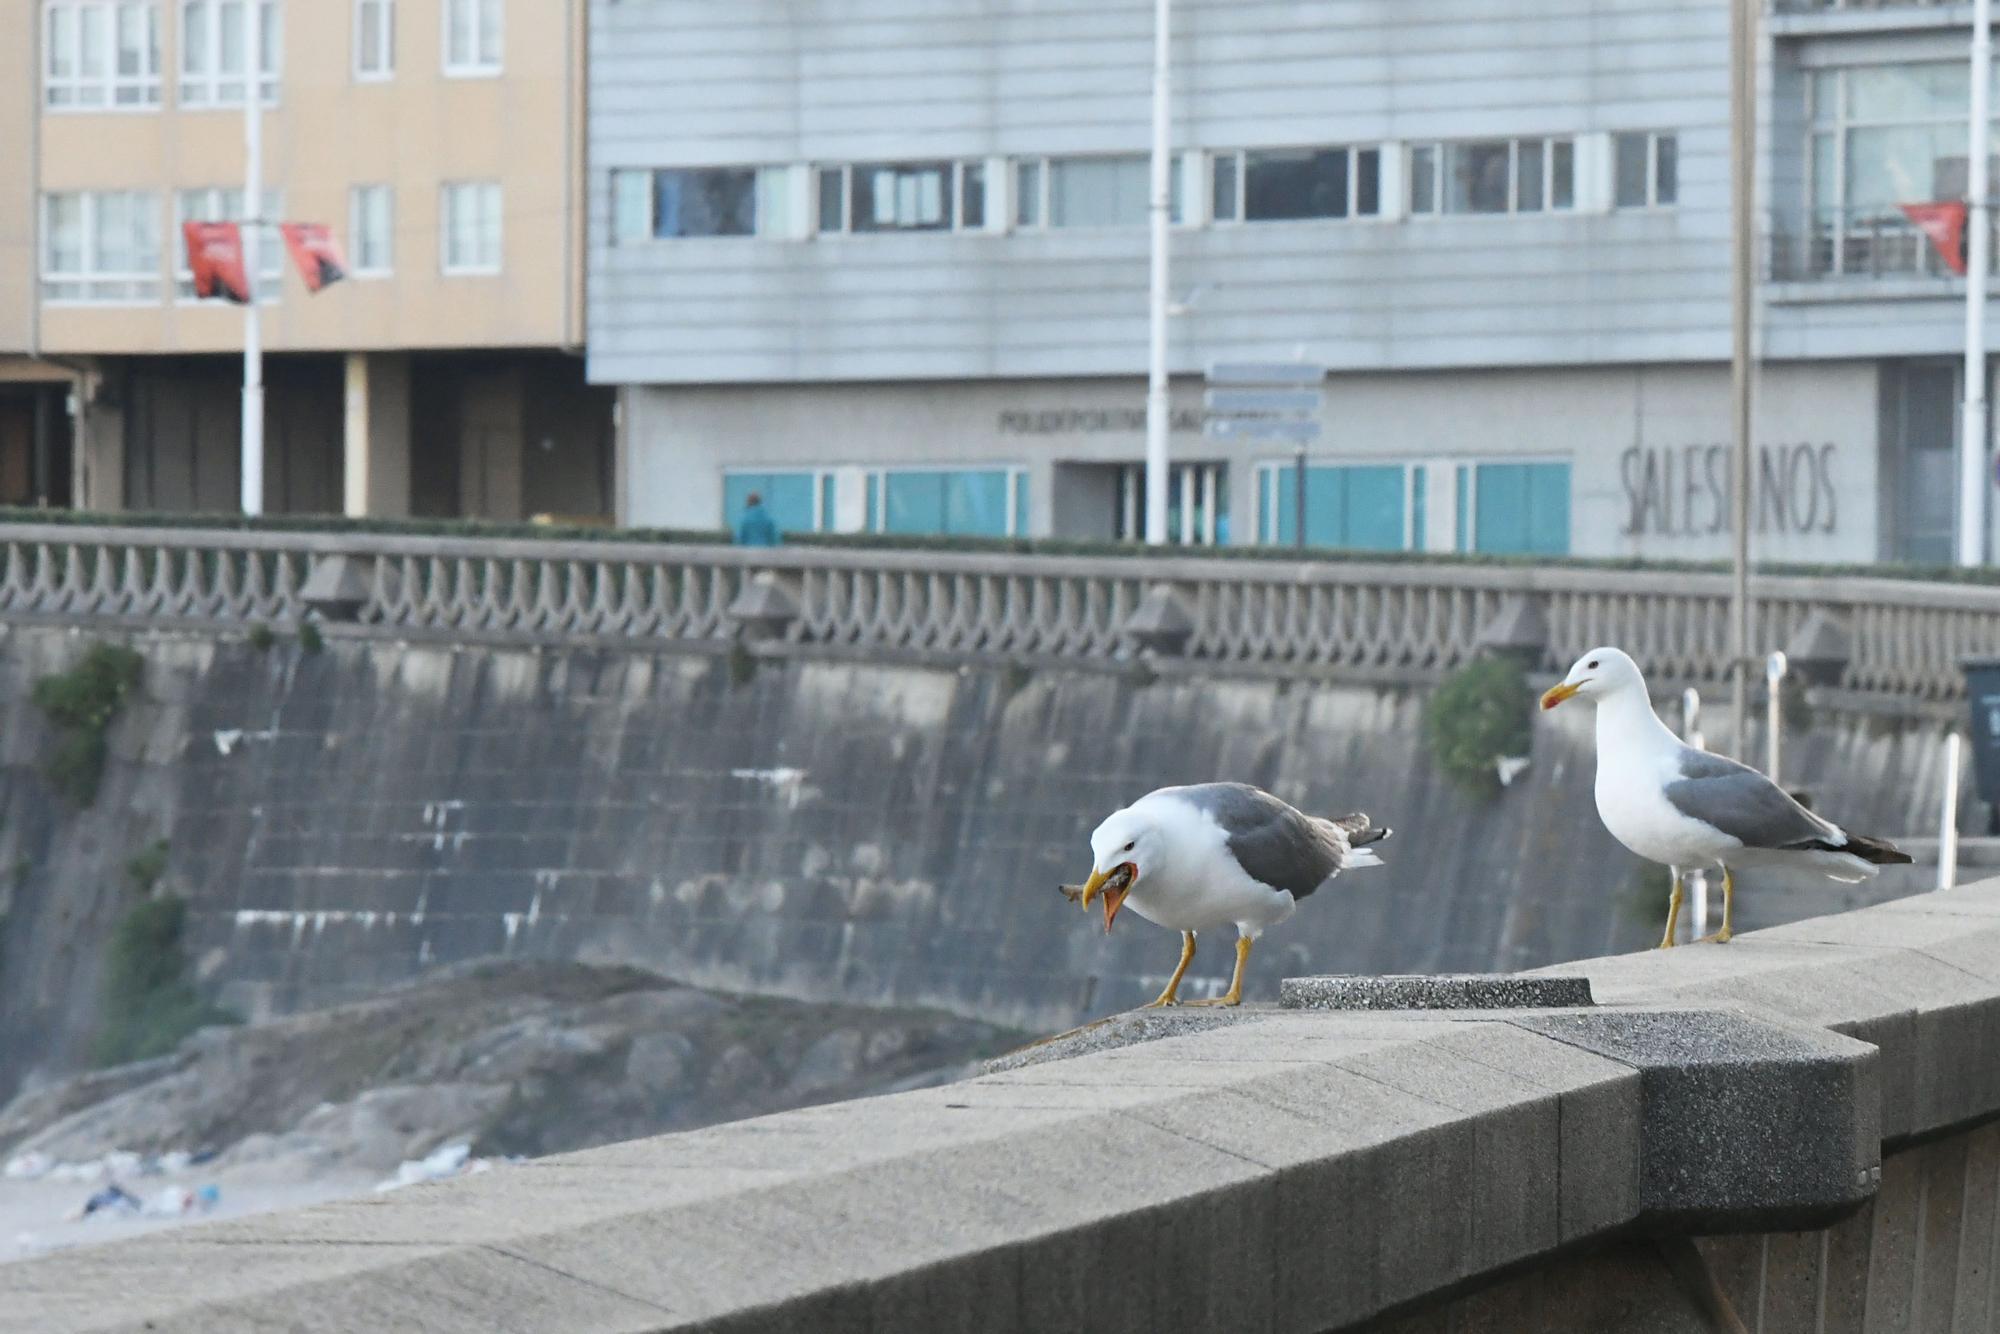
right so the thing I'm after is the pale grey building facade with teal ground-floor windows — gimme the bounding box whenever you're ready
[588,0,2000,560]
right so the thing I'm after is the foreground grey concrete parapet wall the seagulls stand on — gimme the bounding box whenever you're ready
[0,880,2000,1334]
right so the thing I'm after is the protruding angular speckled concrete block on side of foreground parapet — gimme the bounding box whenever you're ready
[1516,1010,1880,1232]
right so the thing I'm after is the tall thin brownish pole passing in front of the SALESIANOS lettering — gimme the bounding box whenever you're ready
[1730,0,1756,760]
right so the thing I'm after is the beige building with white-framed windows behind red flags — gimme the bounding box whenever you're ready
[0,0,616,518]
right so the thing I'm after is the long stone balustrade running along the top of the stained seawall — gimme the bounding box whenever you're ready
[0,524,2000,700]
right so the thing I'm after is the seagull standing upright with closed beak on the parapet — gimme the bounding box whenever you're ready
[1542,648,1910,950]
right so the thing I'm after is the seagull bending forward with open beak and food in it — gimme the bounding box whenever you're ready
[1062,782,1390,1010]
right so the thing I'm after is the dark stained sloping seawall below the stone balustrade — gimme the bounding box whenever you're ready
[0,624,1970,1096]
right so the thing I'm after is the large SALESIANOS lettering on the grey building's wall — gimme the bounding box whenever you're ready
[1618,444,1840,538]
